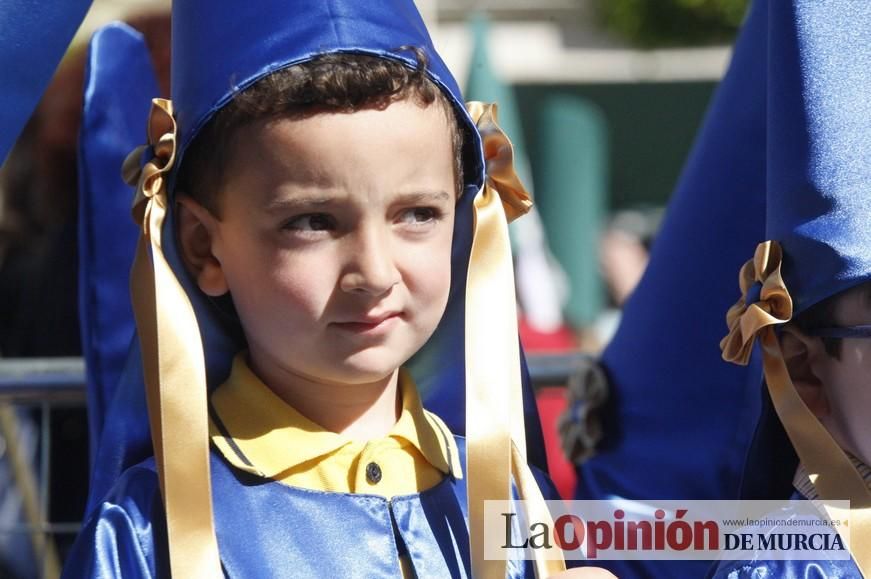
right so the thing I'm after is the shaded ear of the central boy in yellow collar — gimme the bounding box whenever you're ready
[177,195,229,297]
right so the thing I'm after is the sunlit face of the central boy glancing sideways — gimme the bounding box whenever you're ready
[189,100,456,388]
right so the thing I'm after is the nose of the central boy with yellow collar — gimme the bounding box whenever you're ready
[339,232,401,296]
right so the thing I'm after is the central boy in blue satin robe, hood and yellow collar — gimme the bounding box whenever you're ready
[66,0,600,577]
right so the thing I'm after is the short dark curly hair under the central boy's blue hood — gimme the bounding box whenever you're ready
[176,47,464,216]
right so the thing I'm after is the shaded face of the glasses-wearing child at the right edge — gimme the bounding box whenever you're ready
[817,288,871,464]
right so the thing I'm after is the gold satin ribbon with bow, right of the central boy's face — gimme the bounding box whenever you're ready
[465,102,565,579]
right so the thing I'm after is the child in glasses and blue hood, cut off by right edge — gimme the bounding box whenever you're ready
[715,0,871,579]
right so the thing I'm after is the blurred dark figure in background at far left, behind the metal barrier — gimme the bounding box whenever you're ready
[0,51,85,358]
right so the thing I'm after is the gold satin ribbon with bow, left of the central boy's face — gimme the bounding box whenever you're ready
[123,99,223,579]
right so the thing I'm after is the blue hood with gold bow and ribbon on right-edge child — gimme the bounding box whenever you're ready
[721,0,871,570]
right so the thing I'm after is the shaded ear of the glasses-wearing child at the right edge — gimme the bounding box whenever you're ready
[780,324,829,418]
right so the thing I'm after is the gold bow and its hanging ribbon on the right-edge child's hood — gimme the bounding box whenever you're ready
[720,241,871,576]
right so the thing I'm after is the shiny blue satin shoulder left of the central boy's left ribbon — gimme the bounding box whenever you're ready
[63,458,168,579]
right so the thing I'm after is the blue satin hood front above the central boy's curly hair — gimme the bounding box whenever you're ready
[172,0,483,187]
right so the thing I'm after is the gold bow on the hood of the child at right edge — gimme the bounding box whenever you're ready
[720,241,792,366]
